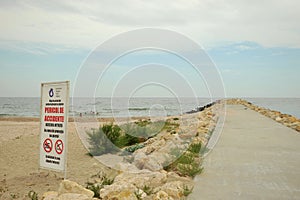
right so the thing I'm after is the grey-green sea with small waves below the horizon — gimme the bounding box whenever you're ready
[0,97,300,118]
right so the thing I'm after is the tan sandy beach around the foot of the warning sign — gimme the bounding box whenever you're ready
[0,117,116,199]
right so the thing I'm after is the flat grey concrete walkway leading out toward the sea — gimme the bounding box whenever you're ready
[189,105,300,200]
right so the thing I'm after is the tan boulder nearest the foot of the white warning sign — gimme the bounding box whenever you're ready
[58,180,94,199]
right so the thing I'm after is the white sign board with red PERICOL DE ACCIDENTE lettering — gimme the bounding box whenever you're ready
[40,81,69,171]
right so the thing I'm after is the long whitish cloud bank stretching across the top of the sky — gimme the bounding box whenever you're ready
[0,0,300,49]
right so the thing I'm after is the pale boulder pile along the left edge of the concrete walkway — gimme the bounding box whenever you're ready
[42,104,220,200]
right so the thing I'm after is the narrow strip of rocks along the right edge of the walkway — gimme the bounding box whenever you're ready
[226,99,300,132]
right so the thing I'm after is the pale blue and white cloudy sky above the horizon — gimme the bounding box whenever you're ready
[0,0,300,98]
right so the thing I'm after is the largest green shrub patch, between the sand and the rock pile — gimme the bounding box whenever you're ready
[87,119,179,156]
